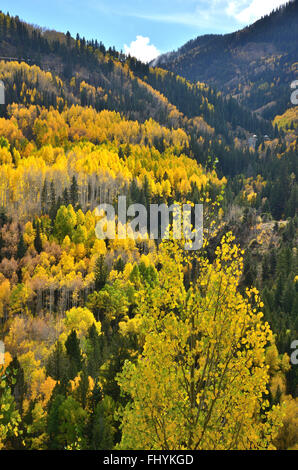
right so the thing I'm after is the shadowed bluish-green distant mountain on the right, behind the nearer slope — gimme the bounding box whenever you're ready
[153,0,298,119]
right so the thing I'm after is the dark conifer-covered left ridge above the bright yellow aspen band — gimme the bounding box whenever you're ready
[0,8,278,180]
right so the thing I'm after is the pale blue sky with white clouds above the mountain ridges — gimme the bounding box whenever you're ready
[0,0,286,62]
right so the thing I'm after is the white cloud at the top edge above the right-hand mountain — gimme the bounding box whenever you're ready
[226,0,286,24]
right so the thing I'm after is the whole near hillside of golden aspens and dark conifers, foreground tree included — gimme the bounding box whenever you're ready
[0,6,298,450]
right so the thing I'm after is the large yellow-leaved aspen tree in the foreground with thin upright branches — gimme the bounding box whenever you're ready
[118,234,282,450]
